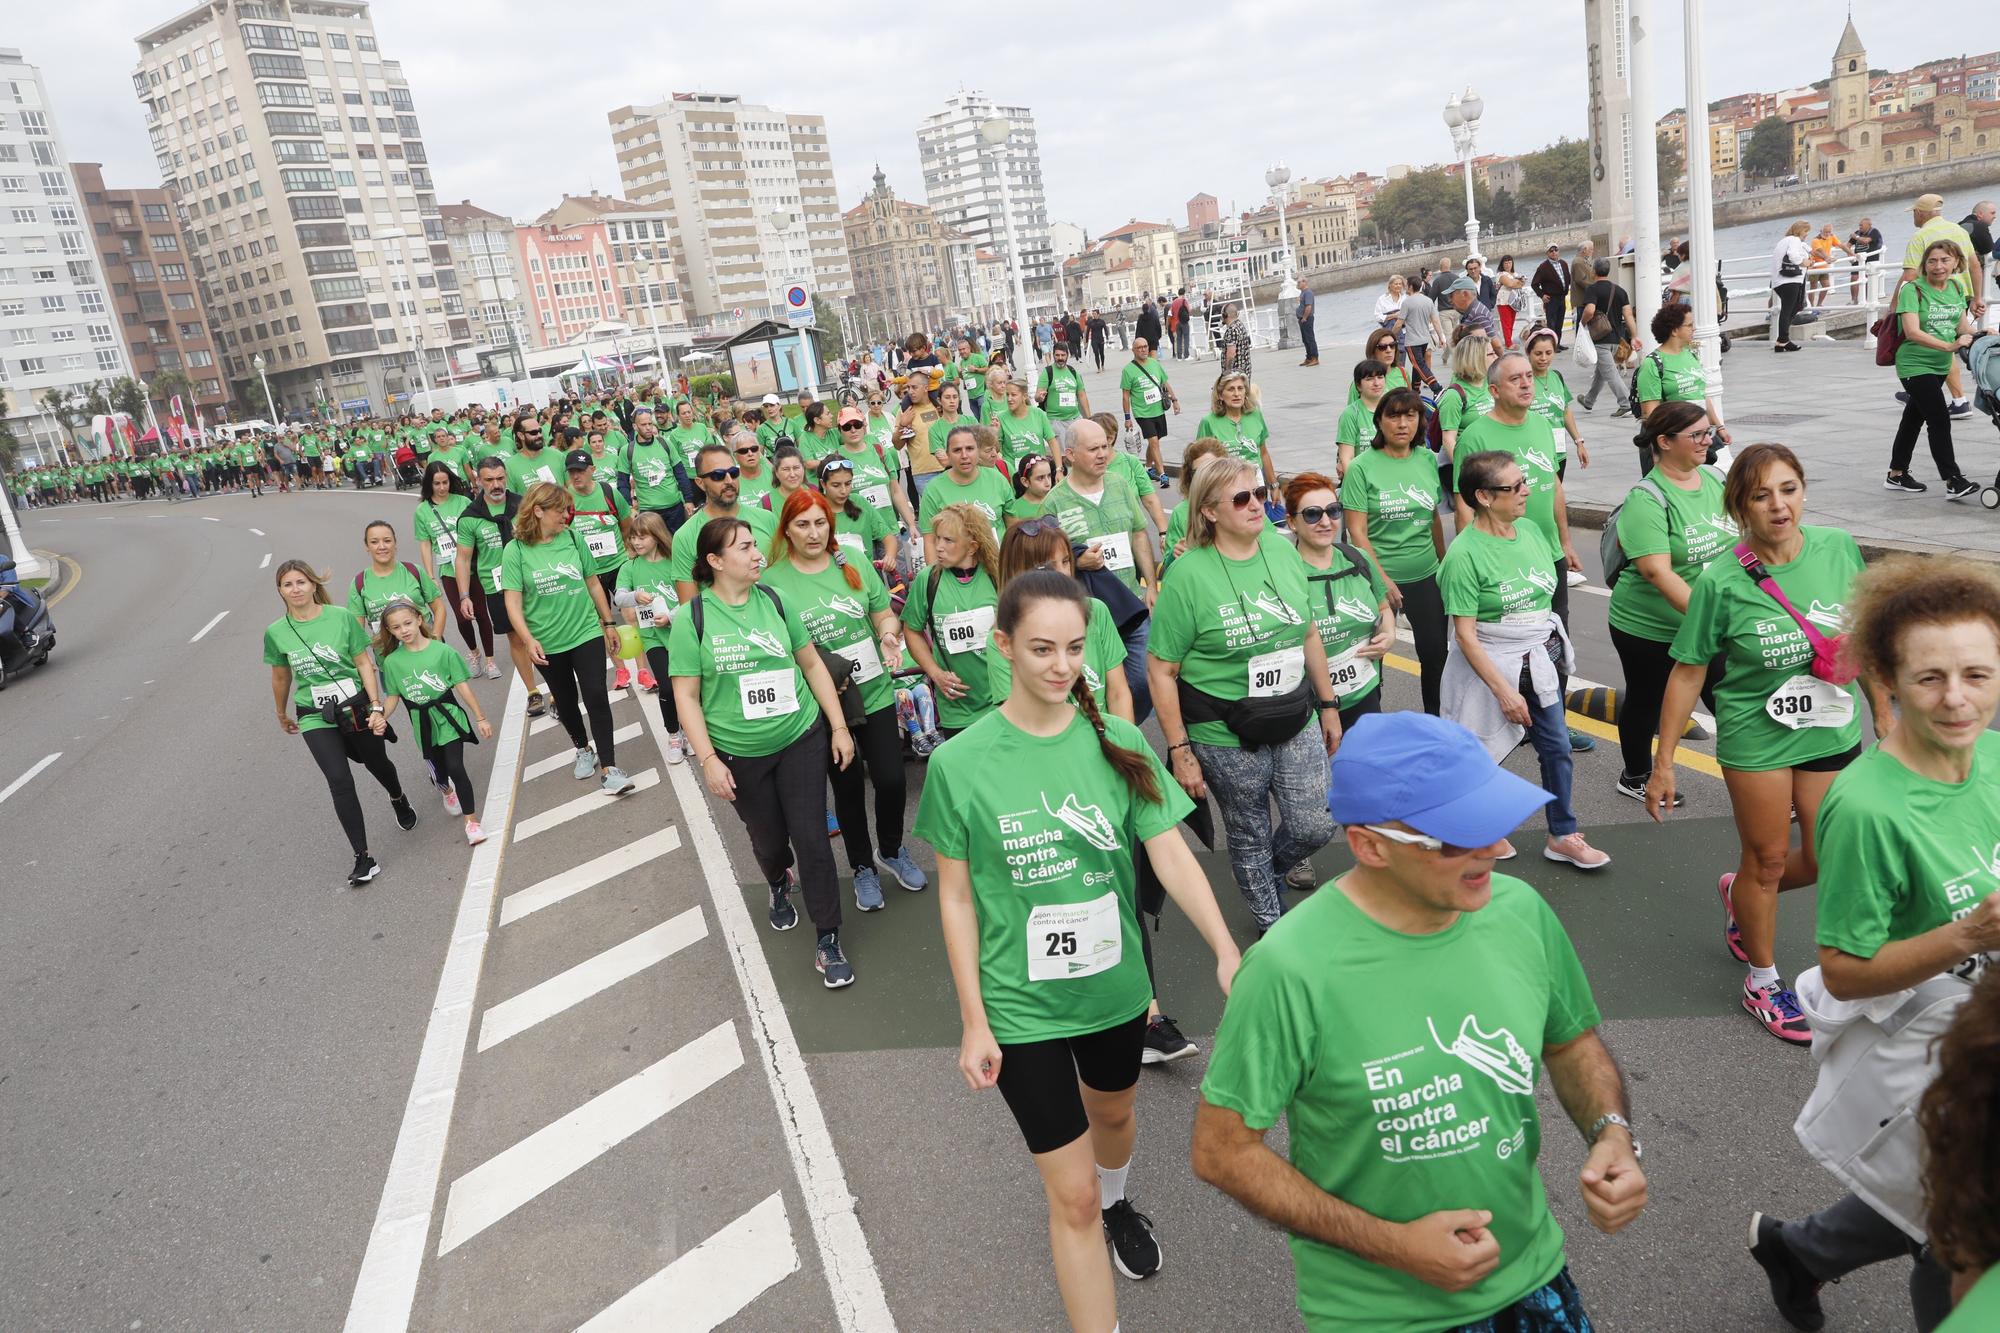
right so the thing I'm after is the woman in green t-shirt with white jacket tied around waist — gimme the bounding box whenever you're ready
[1438,448,1612,871]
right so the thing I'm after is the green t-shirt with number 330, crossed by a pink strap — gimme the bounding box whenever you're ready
[1664,526,1862,773]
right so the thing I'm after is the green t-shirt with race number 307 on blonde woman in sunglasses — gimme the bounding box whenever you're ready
[1148,524,1310,749]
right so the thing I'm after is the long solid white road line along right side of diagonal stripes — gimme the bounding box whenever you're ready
[644,676,896,1333]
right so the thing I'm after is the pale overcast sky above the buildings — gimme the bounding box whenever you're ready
[19,0,1964,234]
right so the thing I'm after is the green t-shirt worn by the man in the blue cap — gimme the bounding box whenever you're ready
[1202,875,1598,1333]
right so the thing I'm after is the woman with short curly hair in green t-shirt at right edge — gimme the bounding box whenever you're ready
[1750,556,2000,1304]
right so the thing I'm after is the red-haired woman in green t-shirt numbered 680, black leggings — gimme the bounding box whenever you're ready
[762,482,928,913]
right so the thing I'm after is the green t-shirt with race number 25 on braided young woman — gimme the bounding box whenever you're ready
[914,713,1194,1045]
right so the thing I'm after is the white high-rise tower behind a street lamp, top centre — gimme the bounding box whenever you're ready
[916,92,1058,314]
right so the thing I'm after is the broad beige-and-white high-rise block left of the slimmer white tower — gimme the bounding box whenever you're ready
[608,92,854,322]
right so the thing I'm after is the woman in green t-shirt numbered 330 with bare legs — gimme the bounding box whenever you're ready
[1646,444,1888,1045]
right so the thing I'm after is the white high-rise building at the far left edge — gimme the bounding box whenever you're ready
[0,46,132,460]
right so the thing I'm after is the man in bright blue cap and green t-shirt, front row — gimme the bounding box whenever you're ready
[1194,713,1646,1333]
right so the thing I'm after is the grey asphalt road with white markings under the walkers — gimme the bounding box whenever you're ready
[0,492,1908,1331]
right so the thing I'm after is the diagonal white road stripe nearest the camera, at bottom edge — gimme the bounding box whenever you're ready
[576,1195,798,1333]
